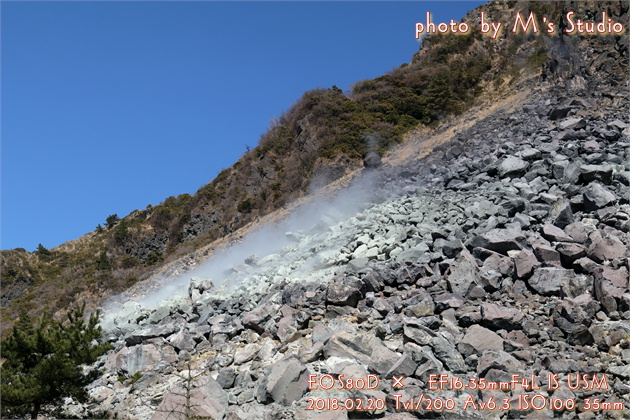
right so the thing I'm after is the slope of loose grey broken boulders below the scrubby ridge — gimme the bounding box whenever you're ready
[67,83,630,420]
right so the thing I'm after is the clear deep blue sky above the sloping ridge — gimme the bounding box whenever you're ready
[0,1,484,251]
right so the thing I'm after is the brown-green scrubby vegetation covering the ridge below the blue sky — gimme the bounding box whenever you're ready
[0,2,627,331]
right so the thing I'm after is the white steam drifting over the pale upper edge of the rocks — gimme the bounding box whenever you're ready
[103,171,386,328]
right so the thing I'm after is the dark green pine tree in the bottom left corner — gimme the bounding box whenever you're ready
[0,303,111,419]
